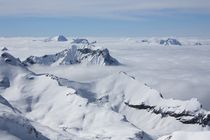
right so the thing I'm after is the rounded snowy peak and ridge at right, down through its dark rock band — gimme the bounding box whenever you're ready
[97,72,210,126]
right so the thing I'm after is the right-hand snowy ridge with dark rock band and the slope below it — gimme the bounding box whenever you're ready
[56,72,209,137]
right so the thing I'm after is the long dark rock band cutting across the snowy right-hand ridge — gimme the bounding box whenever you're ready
[125,102,210,126]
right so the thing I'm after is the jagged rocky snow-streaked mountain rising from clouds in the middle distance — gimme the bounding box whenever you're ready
[23,45,119,65]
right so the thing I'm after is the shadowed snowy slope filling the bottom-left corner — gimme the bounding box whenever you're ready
[0,95,48,140]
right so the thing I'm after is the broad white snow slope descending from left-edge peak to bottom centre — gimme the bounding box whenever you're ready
[1,53,150,140]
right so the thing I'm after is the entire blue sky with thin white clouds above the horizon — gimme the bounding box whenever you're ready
[0,0,210,37]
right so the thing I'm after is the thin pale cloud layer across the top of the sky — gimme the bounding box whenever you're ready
[0,0,210,19]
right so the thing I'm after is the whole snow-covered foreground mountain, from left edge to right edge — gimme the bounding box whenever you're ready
[0,53,210,140]
